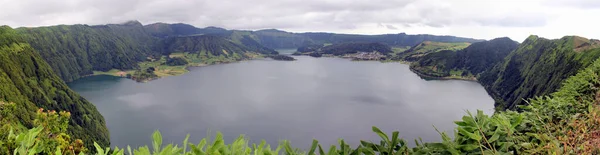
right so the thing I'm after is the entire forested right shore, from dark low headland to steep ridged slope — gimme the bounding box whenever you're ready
[404,36,600,110]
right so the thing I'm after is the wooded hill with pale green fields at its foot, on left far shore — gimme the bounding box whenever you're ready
[122,34,278,82]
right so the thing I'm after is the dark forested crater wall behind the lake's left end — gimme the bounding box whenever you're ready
[17,21,158,82]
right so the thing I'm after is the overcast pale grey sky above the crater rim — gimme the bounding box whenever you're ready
[0,0,600,42]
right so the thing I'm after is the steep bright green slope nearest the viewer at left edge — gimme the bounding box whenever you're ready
[0,26,110,151]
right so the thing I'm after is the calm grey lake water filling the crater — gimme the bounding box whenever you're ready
[69,57,493,148]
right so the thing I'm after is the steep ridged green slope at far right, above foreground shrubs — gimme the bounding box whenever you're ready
[479,36,600,109]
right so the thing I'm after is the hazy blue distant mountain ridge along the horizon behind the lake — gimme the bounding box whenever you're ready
[138,23,483,49]
